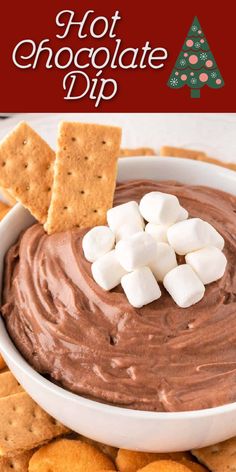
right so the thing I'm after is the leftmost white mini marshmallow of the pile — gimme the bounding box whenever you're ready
[82,226,115,262]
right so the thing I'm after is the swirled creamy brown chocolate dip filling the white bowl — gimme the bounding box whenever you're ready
[2,181,236,411]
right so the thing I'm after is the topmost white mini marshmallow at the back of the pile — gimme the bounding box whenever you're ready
[139,192,180,226]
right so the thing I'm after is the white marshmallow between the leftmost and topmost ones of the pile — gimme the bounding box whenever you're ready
[107,201,144,233]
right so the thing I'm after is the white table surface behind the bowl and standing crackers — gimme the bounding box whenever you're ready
[0,113,236,162]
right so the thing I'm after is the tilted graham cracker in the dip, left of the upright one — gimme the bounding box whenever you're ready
[0,122,55,223]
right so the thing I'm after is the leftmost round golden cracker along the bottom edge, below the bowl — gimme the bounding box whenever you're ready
[29,439,115,472]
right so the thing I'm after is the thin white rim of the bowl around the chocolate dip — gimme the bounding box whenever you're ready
[0,156,236,421]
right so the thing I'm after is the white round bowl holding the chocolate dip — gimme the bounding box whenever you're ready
[0,157,236,452]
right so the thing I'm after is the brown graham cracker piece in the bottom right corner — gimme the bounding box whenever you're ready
[191,437,236,472]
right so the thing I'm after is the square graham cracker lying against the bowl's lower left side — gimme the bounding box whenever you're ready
[0,392,68,457]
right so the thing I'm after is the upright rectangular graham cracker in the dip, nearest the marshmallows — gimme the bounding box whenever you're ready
[45,122,121,234]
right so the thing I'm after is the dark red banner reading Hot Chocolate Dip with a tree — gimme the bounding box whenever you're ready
[0,0,236,113]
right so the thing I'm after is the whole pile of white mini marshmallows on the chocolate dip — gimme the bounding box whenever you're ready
[82,192,227,308]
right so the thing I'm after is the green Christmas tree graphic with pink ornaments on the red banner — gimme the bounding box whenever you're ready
[167,17,224,98]
